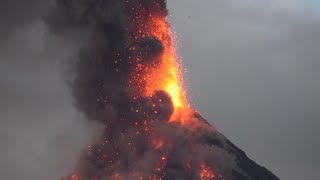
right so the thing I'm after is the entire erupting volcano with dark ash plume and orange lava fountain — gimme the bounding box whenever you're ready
[49,0,278,180]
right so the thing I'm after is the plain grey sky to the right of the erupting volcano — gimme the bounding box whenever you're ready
[169,0,320,180]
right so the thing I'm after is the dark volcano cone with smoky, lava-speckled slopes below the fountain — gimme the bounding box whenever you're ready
[65,113,279,180]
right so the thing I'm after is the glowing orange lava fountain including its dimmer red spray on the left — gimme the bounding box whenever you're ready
[130,5,189,122]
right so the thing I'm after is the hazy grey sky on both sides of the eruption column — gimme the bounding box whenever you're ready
[0,0,320,180]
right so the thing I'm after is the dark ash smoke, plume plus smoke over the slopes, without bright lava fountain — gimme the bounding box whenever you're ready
[47,0,238,179]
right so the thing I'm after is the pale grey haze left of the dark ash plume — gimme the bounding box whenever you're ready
[0,0,102,180]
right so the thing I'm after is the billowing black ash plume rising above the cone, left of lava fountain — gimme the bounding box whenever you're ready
[50,0,173,124]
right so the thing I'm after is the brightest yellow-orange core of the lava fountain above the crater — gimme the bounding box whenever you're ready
[142,17,188,108]
